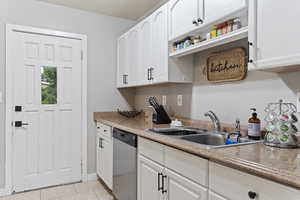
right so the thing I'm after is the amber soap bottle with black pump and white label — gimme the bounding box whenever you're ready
[248,108,261,140]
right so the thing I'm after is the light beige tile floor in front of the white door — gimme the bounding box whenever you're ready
[0,181,113,200]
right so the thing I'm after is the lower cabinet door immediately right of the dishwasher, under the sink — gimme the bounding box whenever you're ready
[138,155,163,200]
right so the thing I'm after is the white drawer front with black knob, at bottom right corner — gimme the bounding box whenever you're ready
[209,162,300,200]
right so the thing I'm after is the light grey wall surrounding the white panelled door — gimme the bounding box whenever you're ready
[0,0,134,188]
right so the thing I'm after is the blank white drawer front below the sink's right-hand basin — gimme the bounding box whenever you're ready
[165,147,208,186]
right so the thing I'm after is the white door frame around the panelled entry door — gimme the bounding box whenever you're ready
[4,24,88,196]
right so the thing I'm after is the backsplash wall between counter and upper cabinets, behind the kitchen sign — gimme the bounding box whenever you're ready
[135,40,300,125]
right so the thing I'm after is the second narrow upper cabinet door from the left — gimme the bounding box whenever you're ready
[126,28,140,86]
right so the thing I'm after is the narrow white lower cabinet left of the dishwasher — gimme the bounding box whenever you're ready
[97,123,113,189]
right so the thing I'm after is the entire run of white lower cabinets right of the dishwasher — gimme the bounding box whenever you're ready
[138,138,300,200]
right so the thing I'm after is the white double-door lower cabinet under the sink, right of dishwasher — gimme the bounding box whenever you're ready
[138,138,208,200]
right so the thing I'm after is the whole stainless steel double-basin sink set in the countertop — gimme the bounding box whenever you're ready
[149,128,261,149]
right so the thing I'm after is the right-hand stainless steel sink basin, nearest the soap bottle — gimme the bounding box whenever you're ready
[180,133,262,148]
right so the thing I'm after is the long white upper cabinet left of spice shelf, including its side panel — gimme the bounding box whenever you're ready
[117,4,193,88]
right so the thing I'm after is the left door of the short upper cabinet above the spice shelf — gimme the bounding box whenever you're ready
[168,0,203,40]
